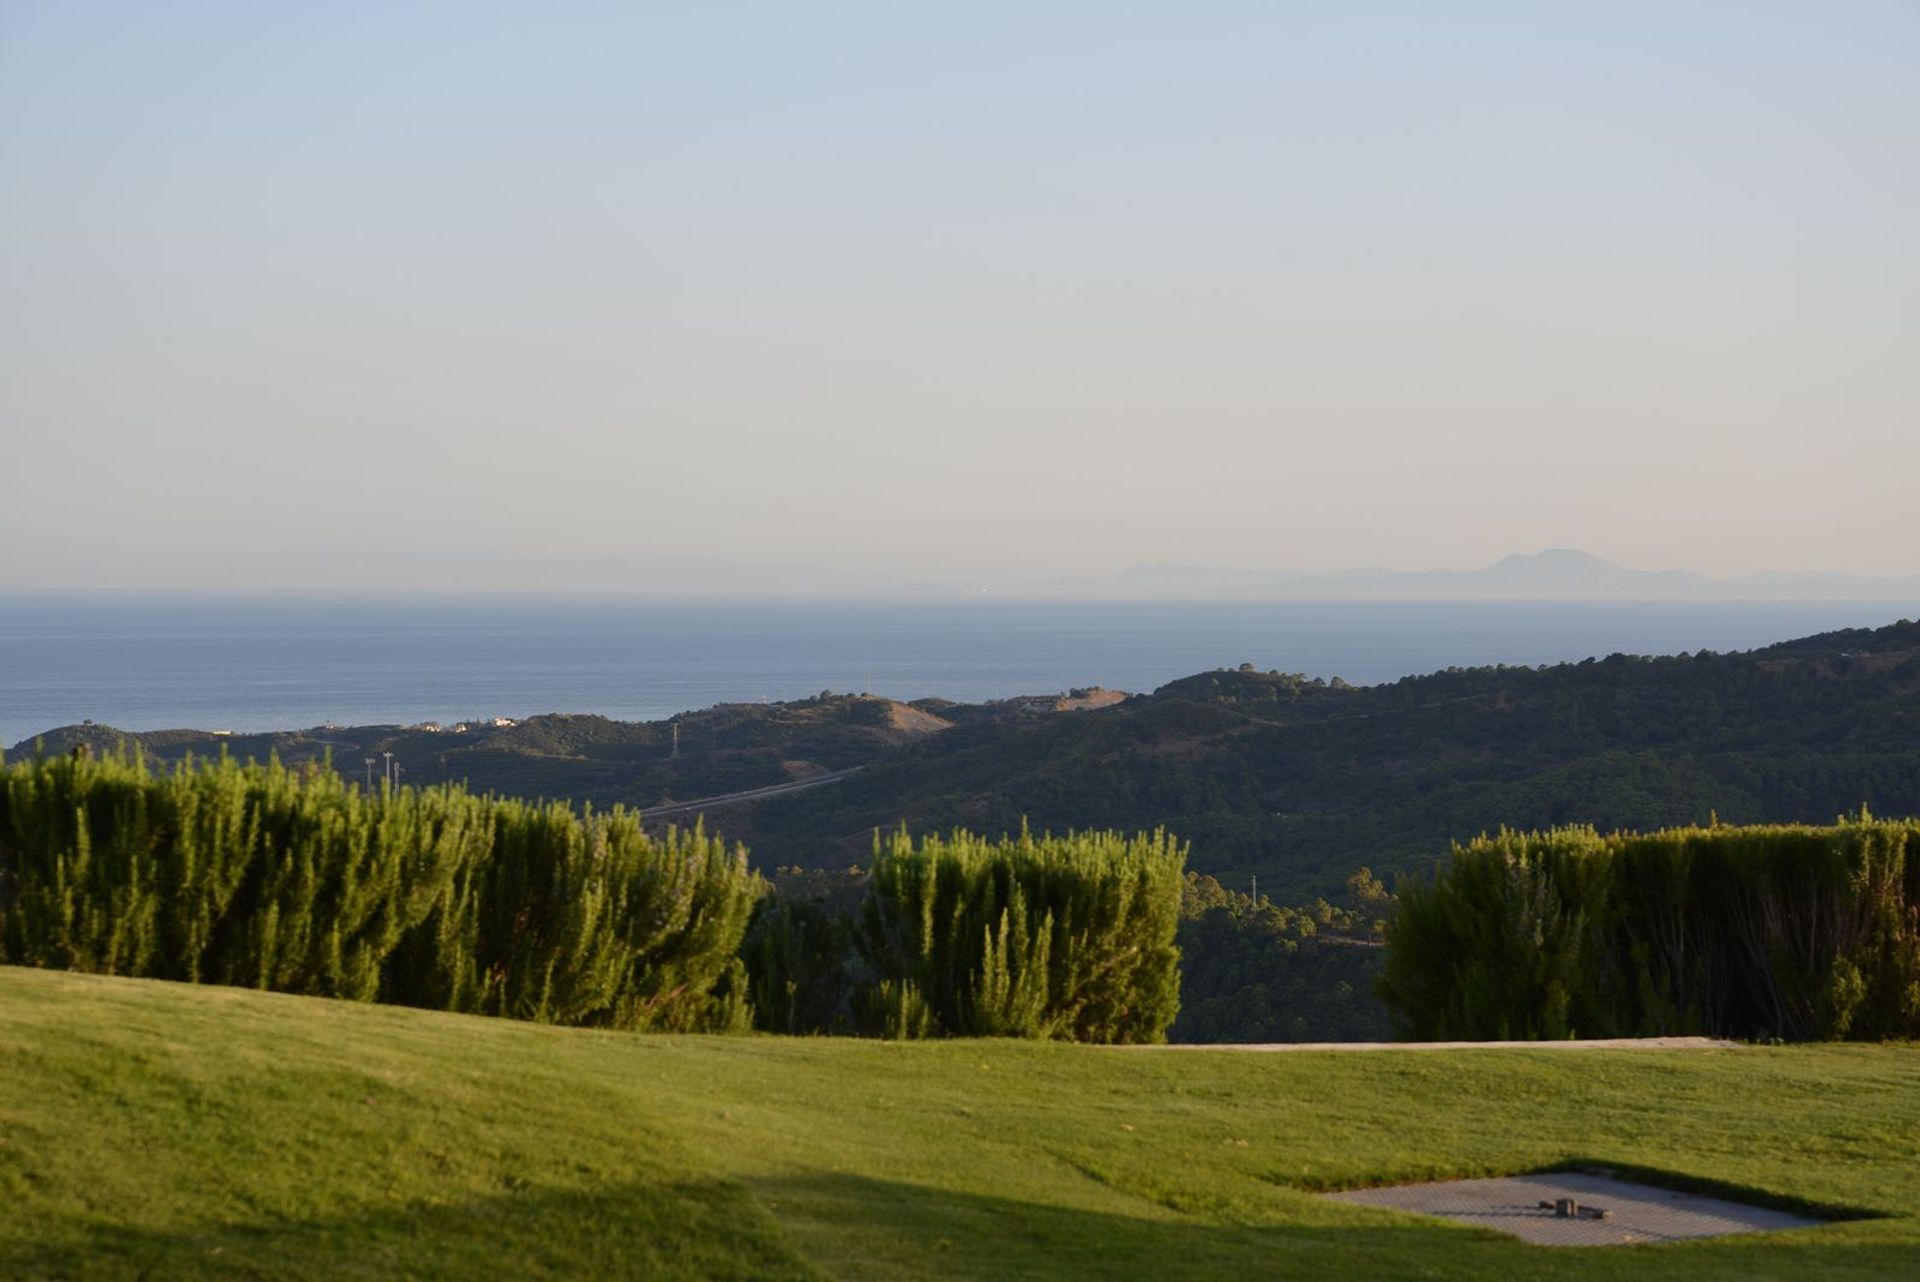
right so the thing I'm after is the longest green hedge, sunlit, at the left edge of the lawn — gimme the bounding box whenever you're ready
[0,750,764,1029]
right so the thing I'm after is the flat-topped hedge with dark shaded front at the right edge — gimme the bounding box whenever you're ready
[1380,812,1920,1040]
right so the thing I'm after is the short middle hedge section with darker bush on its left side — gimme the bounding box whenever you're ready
[745,829,1187,1042]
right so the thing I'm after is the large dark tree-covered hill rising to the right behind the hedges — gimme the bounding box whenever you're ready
[751,624,1920,900]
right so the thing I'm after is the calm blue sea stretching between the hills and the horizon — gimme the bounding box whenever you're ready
[0,597,1920,745]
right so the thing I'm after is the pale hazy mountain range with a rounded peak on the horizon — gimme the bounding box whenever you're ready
[1058,547,1920,601]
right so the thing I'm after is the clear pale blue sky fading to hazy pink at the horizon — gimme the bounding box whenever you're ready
[0,0,1920,587]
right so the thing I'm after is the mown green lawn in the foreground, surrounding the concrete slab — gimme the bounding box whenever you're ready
[0,967,1920,1280]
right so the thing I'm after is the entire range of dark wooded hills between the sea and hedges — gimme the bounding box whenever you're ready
[15,622,1920,902]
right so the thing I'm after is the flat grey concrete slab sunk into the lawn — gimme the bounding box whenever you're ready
[1327,1173,1822,1246]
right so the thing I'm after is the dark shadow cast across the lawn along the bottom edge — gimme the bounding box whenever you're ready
[0,1173,1920,1282]
